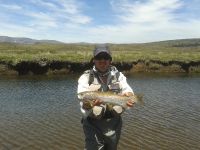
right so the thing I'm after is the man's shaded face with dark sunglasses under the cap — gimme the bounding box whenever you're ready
[94,53,111,72]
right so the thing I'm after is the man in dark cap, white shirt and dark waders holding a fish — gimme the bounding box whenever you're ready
[77,46,134,150]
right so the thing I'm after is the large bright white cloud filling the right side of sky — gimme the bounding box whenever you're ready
[83,0,200,43]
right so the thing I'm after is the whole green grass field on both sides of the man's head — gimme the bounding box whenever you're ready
[0,39,200,64]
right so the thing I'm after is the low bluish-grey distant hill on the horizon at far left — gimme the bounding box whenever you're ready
[0,36,62,44]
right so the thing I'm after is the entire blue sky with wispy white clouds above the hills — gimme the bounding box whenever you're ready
[0,0,200,43]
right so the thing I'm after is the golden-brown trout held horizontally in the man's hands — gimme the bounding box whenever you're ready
[78,91,144,109]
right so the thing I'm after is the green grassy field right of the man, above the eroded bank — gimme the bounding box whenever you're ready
[111,39,200,62]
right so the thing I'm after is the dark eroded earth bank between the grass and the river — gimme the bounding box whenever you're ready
[0,60,200,75]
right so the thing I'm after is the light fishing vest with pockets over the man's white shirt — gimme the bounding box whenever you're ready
[85,66,121,93]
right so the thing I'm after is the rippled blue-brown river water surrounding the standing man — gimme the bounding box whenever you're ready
[0,74,200,150]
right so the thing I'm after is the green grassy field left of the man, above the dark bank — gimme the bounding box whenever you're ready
[0,43,94,64]
